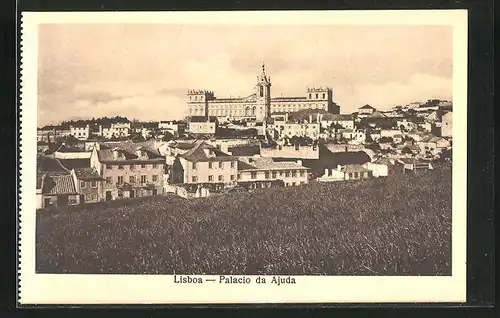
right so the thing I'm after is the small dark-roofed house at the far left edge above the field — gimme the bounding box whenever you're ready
[41,174,80,208]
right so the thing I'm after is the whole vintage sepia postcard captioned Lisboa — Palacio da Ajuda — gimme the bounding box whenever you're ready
[19,10,467,304]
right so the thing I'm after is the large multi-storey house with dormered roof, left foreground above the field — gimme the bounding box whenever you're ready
[90,141,165,201]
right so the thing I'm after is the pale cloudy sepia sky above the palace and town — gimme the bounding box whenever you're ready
[37,24,453,126]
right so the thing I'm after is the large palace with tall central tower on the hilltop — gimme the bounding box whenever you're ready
[187,64,340,121]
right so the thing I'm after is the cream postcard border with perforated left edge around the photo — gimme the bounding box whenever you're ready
[19,10,467,304]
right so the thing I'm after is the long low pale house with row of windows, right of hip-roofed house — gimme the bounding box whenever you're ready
[238,157,309,189]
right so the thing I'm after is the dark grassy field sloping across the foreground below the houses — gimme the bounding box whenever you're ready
[36,167,451,275]
